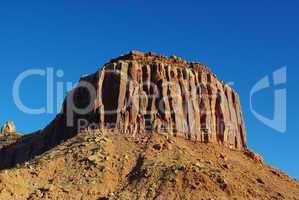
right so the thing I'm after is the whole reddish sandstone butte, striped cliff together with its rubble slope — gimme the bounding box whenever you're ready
[0,51,299,200]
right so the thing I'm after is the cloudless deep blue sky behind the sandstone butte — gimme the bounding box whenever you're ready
[0,0,299,178]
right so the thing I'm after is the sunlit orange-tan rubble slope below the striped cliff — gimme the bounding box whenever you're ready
[0,130,299,200]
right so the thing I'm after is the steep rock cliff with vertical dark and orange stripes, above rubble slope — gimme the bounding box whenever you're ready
[60,52,246,149]
